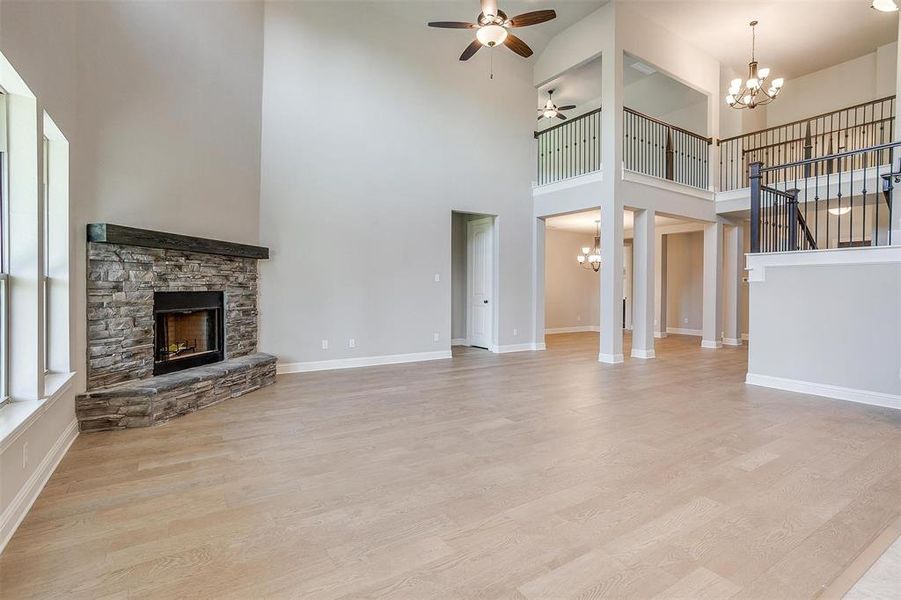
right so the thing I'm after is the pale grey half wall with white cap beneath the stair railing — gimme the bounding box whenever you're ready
[748,247,901,408]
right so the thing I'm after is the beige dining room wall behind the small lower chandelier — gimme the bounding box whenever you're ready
[544,228,600,330]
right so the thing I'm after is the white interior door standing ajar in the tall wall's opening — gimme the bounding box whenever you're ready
[466,218,494,348]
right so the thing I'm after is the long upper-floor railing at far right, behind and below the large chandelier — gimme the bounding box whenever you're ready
[717,96,895,191]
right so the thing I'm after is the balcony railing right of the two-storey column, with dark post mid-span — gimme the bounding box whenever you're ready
[623,108,711,189]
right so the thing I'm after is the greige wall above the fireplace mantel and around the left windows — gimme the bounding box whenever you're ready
[0,0,263,548]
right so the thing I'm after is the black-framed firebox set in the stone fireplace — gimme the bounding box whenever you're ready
[153,292,225,375]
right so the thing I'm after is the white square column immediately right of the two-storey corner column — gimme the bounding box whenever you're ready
[632,210,657,358]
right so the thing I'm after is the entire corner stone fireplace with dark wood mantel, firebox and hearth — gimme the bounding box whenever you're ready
[76,224,275,431]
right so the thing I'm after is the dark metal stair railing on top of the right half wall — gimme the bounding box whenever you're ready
[748,142,901,252]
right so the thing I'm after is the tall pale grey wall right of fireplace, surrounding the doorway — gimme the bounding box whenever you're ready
[261,2,535,364]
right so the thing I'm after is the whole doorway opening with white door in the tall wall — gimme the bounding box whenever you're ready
[451,212,498,352]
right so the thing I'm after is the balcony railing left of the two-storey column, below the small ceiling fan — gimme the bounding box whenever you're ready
[535,108,601,185]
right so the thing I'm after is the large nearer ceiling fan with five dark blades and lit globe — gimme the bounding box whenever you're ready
[429,0,557,60]
